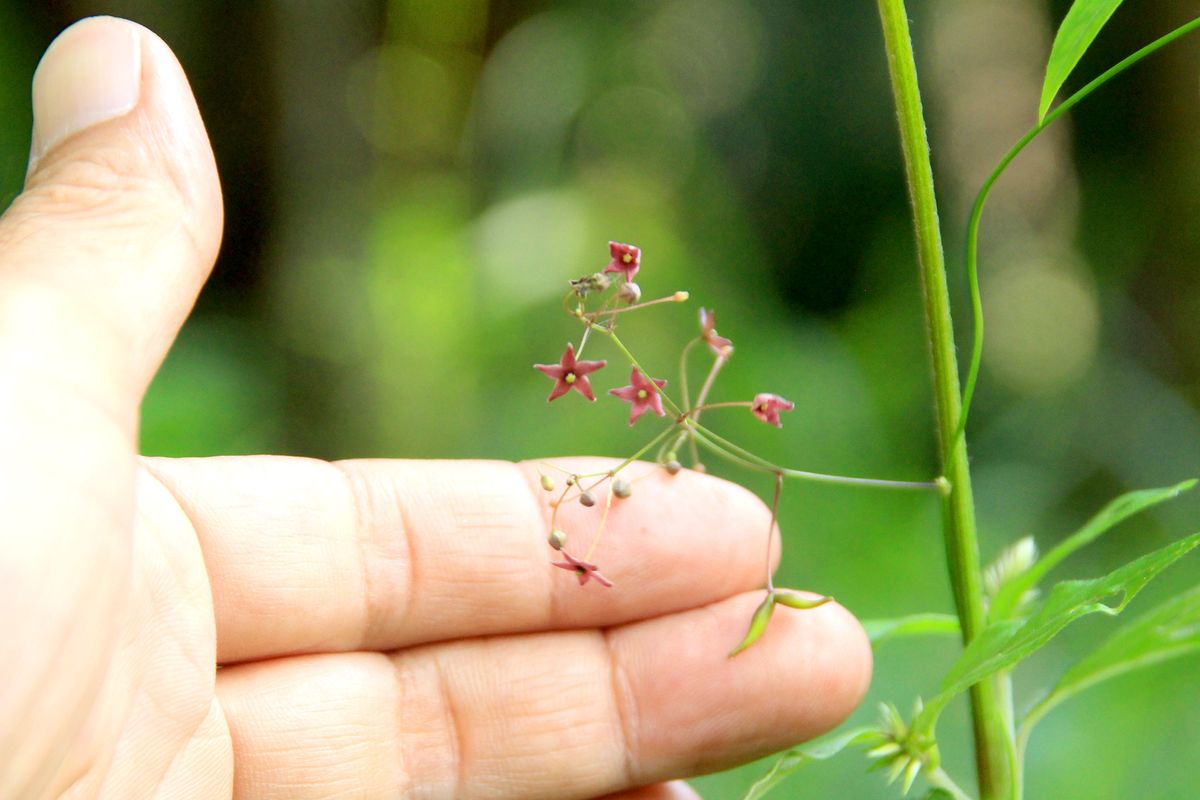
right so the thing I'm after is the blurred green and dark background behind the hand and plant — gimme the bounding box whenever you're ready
[0,0,1200,799]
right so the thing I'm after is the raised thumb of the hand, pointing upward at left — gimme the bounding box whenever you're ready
[0,17,222,411]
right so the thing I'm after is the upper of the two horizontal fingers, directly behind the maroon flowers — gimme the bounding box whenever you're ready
[144,456,779,663]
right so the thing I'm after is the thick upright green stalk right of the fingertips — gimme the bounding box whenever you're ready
[878,0,1013,800]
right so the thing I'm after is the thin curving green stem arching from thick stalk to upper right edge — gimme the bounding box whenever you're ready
[954,18,1200,439]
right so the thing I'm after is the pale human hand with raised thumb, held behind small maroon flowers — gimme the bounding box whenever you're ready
[0,18,870,799]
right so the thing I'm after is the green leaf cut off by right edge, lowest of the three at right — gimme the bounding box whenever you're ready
[1026,587,1200,727]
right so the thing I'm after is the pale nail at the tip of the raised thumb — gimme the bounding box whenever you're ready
[31,17,142,163]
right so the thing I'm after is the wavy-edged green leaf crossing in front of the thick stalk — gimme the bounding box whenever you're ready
[914,534,1200,727]
